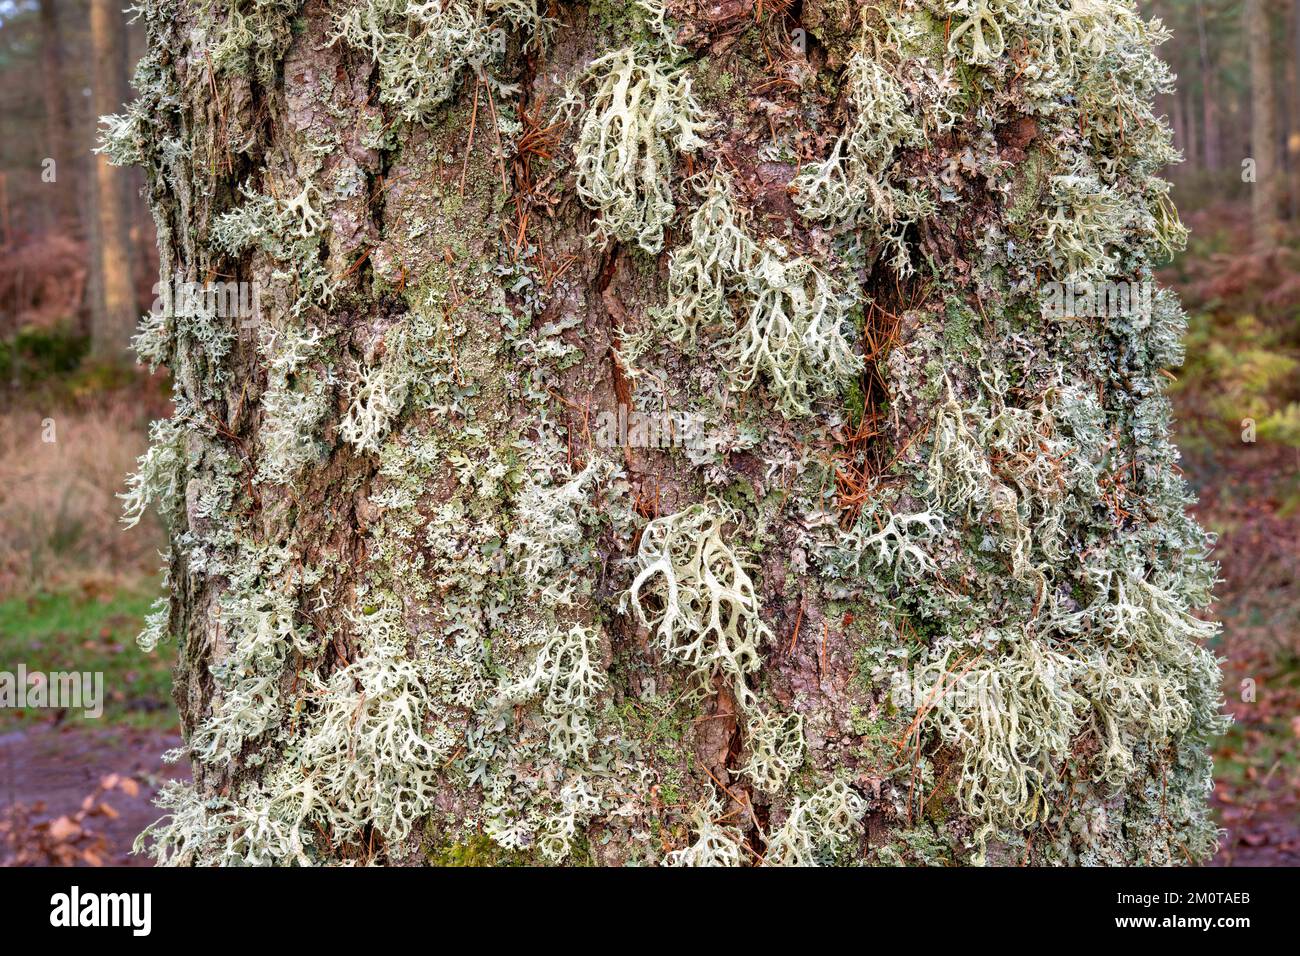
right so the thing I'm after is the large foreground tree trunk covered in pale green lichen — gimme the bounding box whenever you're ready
[109,0,1221,864]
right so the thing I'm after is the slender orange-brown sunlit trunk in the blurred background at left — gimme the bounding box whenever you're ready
[90,0,139,362]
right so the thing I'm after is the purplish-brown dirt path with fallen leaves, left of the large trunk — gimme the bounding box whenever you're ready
[0,723,189,866]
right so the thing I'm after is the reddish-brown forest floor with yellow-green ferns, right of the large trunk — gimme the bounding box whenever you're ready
[1160,203,1300,866]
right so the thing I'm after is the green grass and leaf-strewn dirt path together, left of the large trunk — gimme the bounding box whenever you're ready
[0,579,189,866]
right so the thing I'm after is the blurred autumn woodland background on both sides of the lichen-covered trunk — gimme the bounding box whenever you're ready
[0,0,1300,865]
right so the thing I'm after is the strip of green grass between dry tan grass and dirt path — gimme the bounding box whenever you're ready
[0,587,177,731]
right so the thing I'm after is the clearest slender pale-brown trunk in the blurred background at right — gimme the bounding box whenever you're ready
[1243,0,1283,250]
